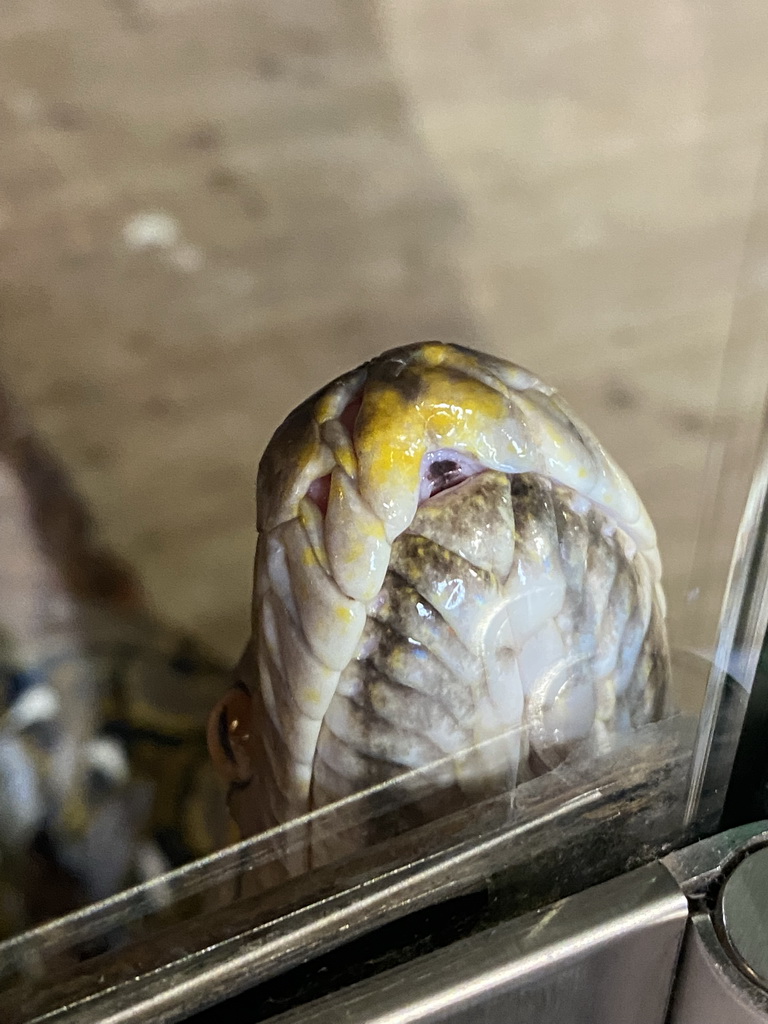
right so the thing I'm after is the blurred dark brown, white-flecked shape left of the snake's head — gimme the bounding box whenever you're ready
[0,390,233,937]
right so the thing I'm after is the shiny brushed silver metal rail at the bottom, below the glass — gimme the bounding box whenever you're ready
[272,863,687,1024]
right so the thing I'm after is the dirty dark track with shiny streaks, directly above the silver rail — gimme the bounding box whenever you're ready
[0,720,694,1024]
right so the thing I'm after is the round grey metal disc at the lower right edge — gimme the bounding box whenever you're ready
[718,847,768,990]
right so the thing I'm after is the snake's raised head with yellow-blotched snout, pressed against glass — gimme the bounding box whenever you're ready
[208,342,670,870]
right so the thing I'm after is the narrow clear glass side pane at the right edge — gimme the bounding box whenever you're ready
[686,138,768,830]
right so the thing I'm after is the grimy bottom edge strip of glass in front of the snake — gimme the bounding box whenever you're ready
[0,718,693,1024]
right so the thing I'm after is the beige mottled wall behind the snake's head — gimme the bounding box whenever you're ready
[0,6,768,679]
